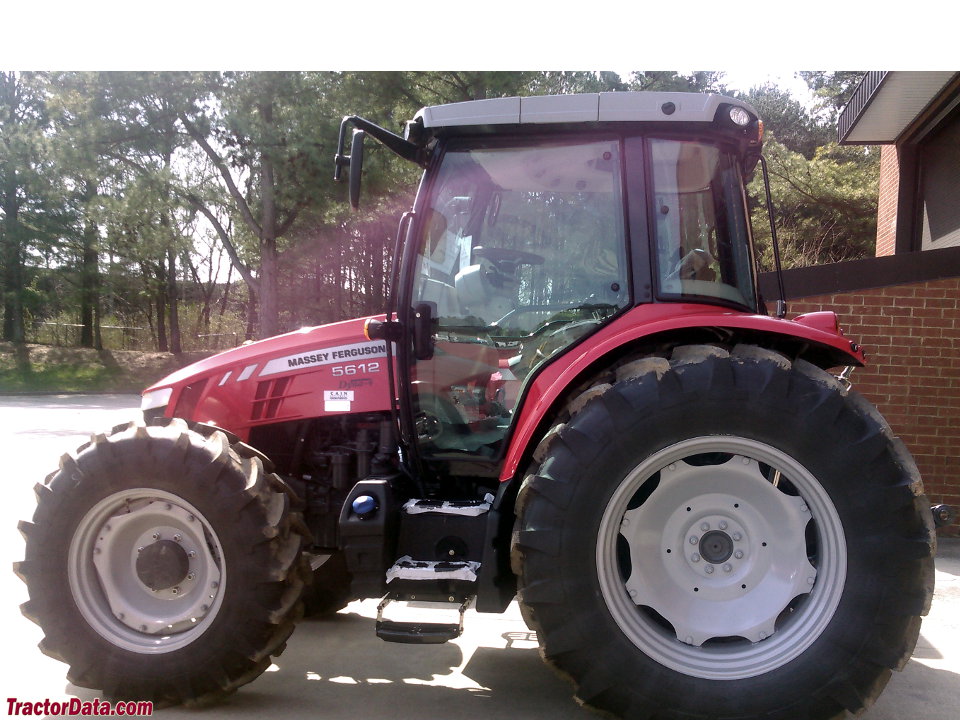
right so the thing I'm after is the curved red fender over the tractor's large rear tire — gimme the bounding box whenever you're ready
[500,303,866,482]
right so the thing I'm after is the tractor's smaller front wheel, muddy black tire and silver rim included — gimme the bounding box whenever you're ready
[15,420,305,705]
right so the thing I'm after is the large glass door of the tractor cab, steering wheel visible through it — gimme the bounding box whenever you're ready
[408,137,629,460]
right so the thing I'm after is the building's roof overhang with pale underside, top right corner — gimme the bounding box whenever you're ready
[838,70,960,145]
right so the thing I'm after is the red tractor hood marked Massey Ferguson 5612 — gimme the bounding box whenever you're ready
[142,315,389,439]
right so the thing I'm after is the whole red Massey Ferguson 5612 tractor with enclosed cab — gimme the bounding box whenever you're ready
[17,93,935,719]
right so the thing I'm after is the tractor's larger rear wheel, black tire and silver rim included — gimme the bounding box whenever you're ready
[513,346,935,720]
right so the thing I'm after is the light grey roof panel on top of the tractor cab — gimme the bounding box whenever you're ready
[417,92,756,128]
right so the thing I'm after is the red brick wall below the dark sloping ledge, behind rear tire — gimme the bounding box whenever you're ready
[790,277,960,535]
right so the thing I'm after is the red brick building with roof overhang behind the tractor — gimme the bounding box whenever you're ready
[761,71,960,535]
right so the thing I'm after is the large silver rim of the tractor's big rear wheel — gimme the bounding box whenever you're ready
[596,436,846,680]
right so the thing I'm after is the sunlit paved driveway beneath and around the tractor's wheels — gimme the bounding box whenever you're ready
[0,395,960,720]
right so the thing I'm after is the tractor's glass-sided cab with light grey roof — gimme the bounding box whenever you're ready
[340,93,762,466]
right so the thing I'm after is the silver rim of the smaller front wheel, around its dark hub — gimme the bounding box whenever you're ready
[67,488,226,654]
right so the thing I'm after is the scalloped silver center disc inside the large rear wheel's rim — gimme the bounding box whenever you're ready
[621,455,816,646]
